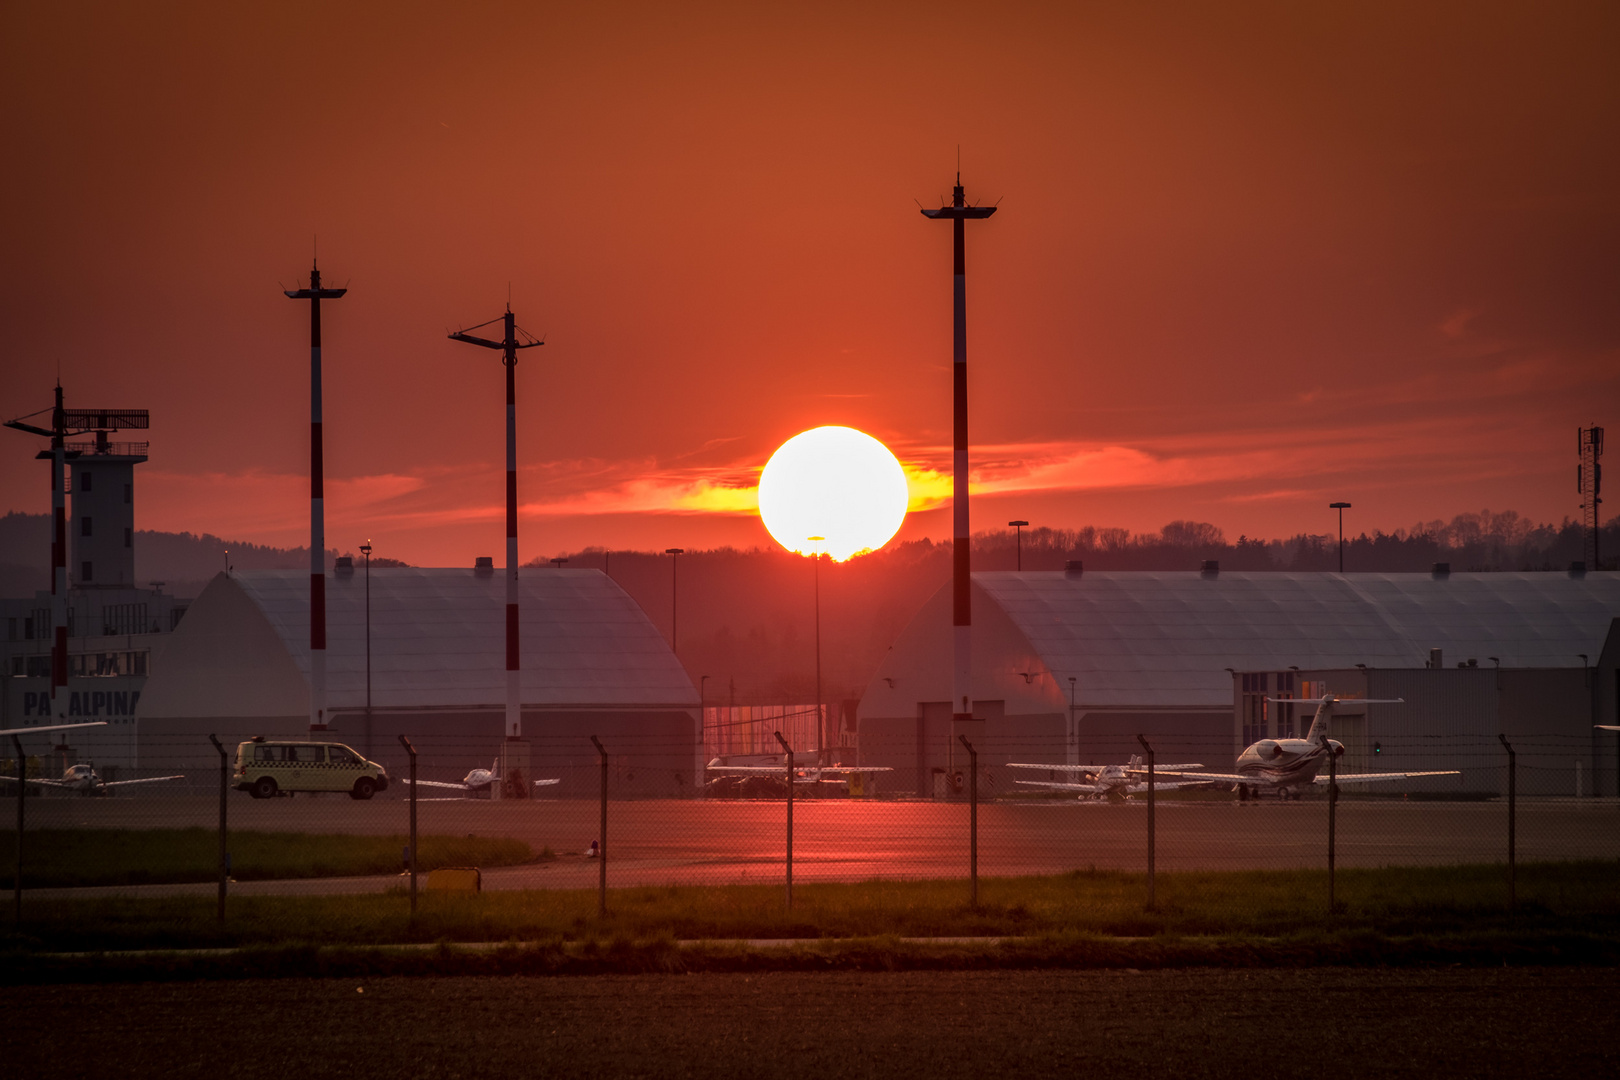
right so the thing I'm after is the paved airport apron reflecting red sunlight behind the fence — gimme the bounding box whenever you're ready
[12,795,1620,894]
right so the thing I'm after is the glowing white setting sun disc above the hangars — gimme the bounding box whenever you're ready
[760,426,907,562]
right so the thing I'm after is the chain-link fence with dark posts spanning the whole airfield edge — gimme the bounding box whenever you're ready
[0,735,1620,939]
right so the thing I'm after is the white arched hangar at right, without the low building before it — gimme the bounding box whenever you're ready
[857,565,1620,795]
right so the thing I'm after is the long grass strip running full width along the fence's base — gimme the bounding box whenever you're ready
[0,860,1620,952]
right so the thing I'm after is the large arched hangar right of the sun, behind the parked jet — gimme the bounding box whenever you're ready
[857,563,1620,797]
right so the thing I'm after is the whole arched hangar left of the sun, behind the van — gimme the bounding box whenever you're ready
[136,559,703,797]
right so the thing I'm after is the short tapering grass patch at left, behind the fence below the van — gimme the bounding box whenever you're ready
[0,829,554,889]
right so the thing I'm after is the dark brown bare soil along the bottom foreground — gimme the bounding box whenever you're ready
[0,968,1620,1080]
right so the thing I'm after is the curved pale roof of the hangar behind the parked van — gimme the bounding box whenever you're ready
[143,567,698,714]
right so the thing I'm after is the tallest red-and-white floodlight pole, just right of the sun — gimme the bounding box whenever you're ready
[922,172,996,761]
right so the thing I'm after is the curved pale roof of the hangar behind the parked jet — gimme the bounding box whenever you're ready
[862,572,1620,716]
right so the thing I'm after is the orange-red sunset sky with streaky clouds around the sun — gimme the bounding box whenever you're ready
[0,2,1620,565]
